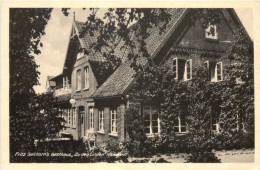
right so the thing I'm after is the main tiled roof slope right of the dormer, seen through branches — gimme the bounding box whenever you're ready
[92,8,185,98]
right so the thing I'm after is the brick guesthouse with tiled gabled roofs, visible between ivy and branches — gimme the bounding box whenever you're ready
[48,8,250,143]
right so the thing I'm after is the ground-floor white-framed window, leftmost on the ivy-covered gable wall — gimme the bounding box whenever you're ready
[143,106,160,135]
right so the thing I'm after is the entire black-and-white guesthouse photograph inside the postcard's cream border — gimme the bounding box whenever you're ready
[1,1,259,167]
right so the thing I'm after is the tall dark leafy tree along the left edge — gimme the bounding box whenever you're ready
[9,8,65,157]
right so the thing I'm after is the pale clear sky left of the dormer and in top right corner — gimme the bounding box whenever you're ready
[34,8,254,93]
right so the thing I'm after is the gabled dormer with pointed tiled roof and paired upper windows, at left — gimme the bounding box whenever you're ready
[59,18,117,96]
